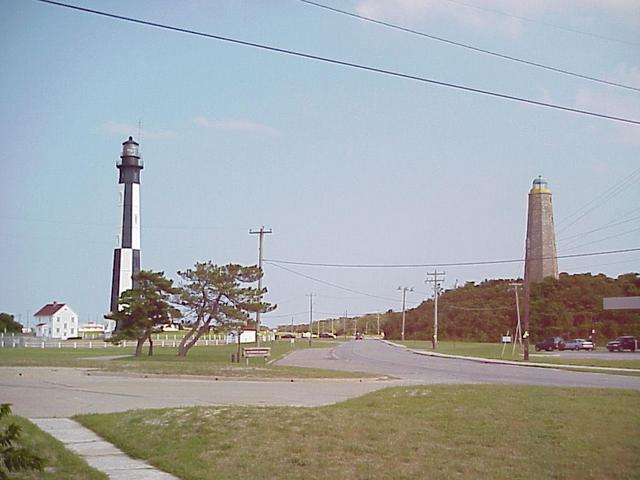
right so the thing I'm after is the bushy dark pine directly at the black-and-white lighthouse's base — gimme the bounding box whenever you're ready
[105,270,181,357]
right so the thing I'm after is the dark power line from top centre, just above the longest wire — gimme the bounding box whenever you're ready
[298,0,640,92]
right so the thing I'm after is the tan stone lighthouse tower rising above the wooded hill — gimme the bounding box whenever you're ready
[524,177,558,283]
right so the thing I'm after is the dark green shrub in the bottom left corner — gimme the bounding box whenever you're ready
[0,403,44,480]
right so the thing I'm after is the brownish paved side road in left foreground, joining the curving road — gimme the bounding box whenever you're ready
[0,367,389,418]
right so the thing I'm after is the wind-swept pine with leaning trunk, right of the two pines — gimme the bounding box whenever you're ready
[178,262,275,357]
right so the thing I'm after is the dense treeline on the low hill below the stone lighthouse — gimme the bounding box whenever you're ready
[372,273,640,344]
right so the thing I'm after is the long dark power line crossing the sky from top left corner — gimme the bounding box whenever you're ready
[37,0,640,125]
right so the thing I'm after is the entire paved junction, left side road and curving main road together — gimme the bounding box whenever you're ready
[0,340,640,418]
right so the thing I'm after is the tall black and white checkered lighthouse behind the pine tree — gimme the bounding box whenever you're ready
[110,137,144,330]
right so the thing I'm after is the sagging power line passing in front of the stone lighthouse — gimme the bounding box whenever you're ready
[265,248,640,270]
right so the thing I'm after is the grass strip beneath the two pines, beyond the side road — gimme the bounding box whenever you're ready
[0,341,372,378]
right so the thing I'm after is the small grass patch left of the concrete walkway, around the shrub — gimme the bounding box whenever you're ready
[0,416,108,480]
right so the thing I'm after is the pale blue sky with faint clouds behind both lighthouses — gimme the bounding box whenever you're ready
[0,0,640,326]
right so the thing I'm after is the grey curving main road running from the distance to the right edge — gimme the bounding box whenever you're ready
[278,340,640,390]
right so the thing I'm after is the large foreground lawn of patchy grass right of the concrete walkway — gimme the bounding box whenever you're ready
[76,385,640,480]
